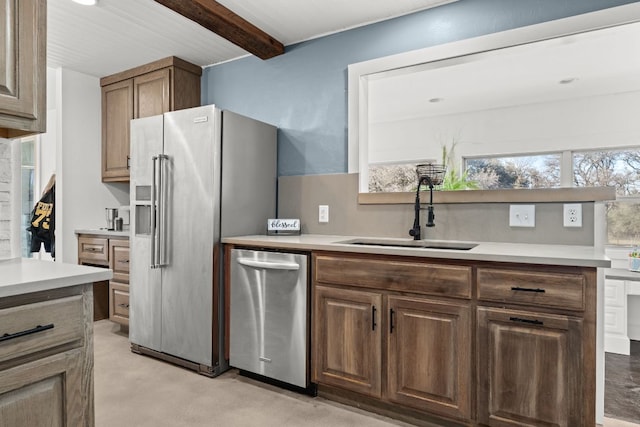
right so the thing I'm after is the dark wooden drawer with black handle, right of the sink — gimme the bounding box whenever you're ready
[478,268,585,310]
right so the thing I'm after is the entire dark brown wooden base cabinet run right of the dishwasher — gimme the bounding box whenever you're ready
[312,251,597,427]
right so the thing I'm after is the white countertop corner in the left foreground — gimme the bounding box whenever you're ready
[0,258,113,298]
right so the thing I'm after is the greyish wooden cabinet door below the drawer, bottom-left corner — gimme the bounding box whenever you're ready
[0,349,84,427]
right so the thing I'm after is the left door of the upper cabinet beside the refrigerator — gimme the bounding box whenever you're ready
[102,79,133,182]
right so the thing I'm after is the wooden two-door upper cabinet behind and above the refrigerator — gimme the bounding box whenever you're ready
[100,56,202,182]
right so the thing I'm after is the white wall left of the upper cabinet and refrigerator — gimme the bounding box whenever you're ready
[48,69,129,263]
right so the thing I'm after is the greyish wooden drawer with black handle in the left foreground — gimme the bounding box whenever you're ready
[0,295,84,362]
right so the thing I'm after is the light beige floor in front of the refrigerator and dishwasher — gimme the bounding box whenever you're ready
[94,320,640,427]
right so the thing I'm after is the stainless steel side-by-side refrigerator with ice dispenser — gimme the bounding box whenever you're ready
[129,105,277,376]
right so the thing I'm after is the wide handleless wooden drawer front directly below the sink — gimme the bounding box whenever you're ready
[314,255,472,298]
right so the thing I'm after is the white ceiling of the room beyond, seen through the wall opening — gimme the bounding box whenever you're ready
[369,19,640,123]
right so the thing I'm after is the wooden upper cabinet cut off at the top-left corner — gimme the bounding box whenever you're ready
[0,0,47,138]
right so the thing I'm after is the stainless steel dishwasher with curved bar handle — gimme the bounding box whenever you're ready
[229,249,309,388]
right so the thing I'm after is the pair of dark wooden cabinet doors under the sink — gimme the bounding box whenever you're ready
[314,286,471,419]
